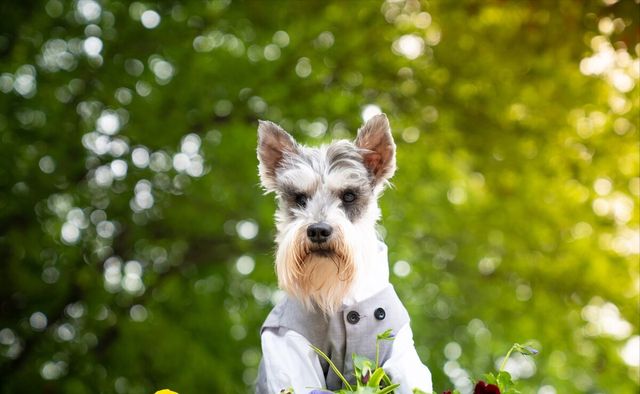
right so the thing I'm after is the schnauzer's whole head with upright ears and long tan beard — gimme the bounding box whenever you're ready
[258,114,396,314]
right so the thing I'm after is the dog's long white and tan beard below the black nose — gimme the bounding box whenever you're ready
[276,226,356,316]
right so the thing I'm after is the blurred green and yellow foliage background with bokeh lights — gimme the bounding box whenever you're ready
[0,0,640,394]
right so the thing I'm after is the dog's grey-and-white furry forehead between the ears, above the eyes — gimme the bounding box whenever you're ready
[278,140,371,191]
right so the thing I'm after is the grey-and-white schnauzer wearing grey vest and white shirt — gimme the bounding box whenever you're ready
[256,114,432,394]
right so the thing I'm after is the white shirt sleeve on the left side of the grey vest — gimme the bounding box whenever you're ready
[262,328,326,394]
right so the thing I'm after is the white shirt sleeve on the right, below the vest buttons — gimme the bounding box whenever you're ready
[382,323,432,394]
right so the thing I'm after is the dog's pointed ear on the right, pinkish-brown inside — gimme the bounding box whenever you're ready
[354,114,396,185]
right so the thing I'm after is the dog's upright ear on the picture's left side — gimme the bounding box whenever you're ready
[258,120,298,192]
